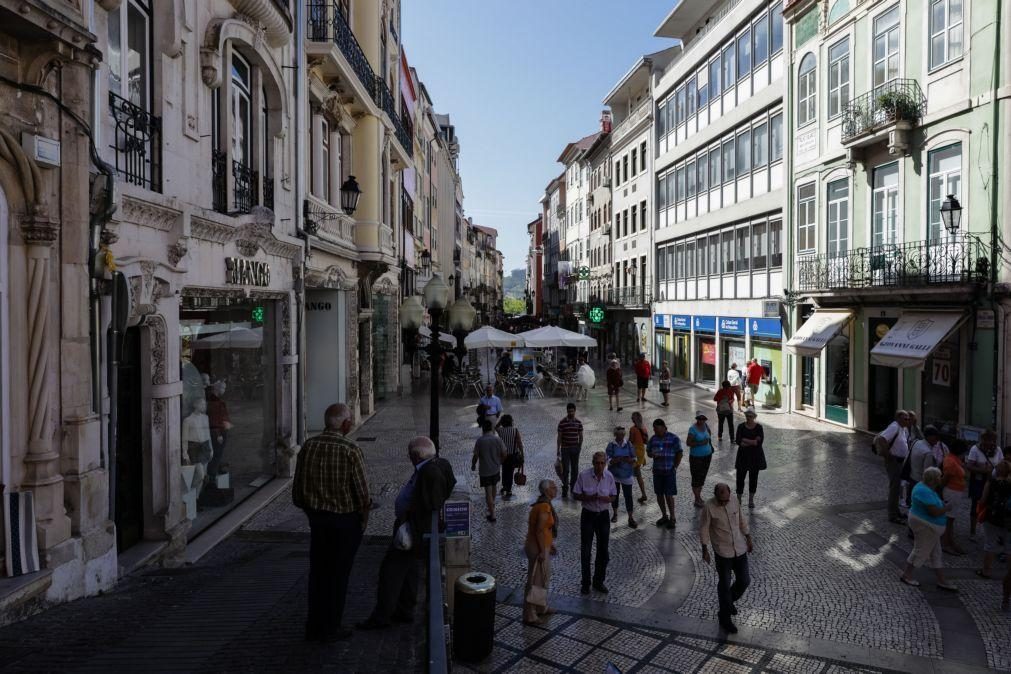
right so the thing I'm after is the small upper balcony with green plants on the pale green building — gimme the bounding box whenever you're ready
[841,80,927,148]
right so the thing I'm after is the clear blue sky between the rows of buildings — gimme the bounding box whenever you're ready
[401,0,675,275]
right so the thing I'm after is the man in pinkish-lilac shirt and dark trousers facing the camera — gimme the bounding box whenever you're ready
[572,452,618,594]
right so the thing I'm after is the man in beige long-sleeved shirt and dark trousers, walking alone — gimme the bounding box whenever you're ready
[699,482,752,635]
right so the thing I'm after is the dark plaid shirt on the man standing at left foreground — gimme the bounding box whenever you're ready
[291,429,371,513]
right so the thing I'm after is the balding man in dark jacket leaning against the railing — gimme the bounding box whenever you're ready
[355,436,456,630]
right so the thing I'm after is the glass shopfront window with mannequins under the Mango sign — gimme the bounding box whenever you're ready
[179,298,277,536]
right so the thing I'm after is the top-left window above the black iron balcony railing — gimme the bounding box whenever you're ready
[108,0,151,111]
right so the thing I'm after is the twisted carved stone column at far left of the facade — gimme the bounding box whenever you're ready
[21,214,71,550]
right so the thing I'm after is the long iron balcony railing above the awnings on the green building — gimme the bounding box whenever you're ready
[797,232,990,292]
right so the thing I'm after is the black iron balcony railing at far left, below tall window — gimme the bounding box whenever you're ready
[109,91,162,192]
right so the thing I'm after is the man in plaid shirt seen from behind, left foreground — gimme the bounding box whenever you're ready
[291,403,372,642]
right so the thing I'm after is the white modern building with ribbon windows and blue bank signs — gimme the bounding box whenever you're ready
[651,0,788,406]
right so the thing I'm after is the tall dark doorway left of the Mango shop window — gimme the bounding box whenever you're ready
[113,327,145,553]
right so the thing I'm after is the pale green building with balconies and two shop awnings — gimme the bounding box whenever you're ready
[786,1,1009,440]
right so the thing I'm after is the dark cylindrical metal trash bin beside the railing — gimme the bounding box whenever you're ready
[453,571,495,662]
